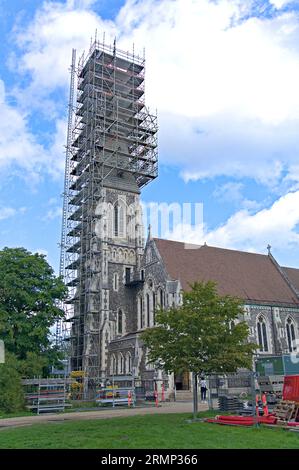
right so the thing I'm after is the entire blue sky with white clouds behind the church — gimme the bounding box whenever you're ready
[0,0,299,274]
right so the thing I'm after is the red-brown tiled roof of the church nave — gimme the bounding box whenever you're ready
[154,238,299,305]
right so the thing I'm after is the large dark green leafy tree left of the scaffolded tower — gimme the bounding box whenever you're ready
[0,248,66,375]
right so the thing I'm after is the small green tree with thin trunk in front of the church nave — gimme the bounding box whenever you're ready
[142,281,256,382]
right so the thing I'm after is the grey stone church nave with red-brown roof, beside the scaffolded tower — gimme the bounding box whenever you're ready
[107,228,299,390]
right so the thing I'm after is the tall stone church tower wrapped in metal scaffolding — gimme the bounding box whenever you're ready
[63,40,157,396]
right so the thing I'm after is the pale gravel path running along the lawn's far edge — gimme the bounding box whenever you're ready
[0,402,208,430]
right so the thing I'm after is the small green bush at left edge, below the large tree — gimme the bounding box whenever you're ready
[0,353,24,413]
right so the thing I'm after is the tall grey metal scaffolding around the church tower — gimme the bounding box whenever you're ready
[62,40,157,396]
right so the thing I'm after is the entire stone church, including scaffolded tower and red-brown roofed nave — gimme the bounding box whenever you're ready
[63,41,299,395]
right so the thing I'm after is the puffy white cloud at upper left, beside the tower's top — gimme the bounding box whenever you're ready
[16,1,115,104]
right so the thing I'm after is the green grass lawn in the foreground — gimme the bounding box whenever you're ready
[0,414,299,449]
